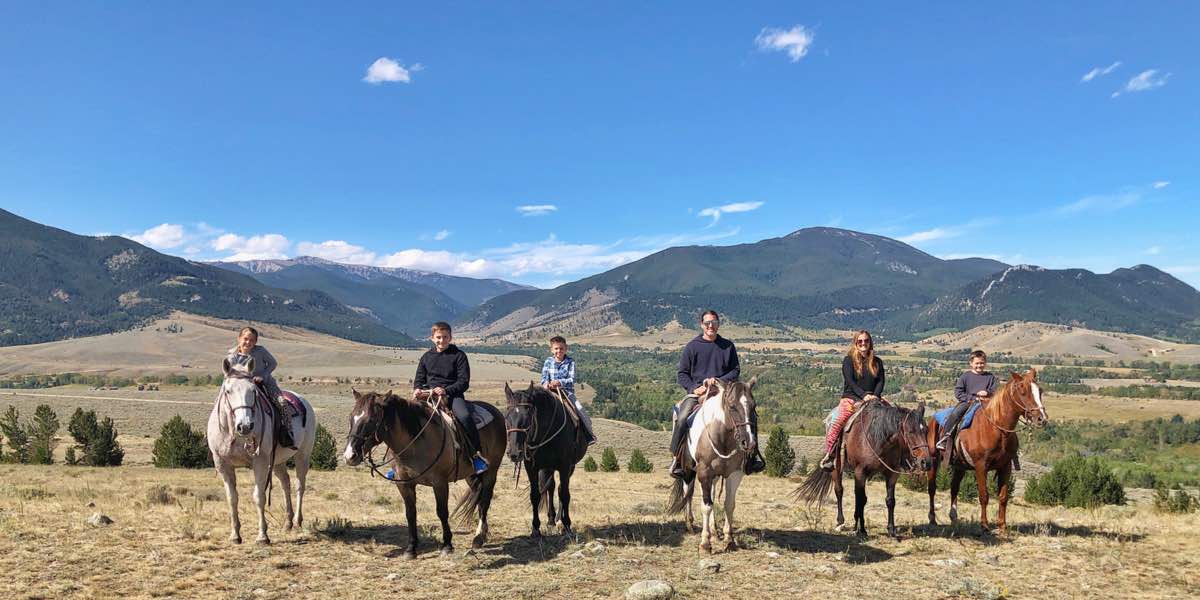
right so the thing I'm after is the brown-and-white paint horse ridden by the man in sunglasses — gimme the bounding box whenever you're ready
[667,377,758,552]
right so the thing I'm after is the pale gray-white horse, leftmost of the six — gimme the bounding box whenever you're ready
[208,360,317,544]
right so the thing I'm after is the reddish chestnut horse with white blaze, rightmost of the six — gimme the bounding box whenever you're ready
[928,368,1049,532]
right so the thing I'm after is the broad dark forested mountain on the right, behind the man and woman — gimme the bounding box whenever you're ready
[464,227,1200,341]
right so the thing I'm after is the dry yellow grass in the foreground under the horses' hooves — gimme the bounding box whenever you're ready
[0,456,1200,599]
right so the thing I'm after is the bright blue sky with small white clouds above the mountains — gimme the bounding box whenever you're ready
[0,2,1200,286]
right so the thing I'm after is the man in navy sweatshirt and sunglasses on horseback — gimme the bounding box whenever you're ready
[671,311,766,478]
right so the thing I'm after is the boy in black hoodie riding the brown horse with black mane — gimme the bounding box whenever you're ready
[413,320,487,475]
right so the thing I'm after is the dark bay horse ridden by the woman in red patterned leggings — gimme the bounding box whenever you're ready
[794,401,932,538]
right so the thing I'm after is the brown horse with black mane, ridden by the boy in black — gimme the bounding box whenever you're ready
[344,391,504,558]
